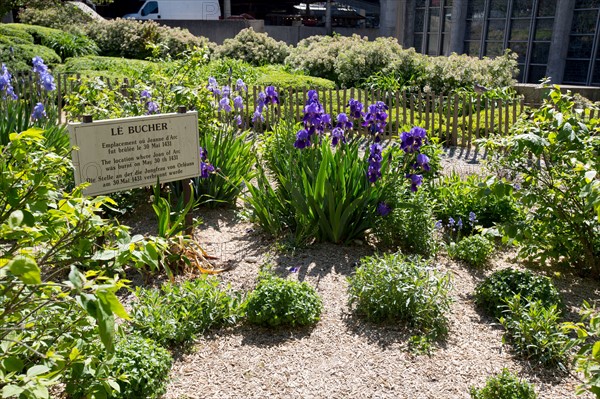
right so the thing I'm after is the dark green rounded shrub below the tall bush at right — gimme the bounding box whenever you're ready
[475,268,562,318]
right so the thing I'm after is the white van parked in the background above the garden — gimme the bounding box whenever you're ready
[123,0,221,20]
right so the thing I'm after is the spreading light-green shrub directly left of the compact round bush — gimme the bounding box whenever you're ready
[131,278,239,345]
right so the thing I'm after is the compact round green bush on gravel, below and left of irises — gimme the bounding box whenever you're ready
[246,273,323,327]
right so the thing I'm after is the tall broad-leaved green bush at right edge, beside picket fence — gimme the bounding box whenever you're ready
[486,87,600,277]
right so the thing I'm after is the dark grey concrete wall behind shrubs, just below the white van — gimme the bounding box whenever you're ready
[160,19,265,44]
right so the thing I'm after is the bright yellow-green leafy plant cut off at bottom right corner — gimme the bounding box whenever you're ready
[564,301,600,398]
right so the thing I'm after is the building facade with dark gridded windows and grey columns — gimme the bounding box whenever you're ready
[380,0,600,86]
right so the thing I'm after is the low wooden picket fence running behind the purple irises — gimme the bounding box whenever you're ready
[15,74,576,147]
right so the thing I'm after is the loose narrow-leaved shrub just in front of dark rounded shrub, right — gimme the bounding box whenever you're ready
[499,295,575,370]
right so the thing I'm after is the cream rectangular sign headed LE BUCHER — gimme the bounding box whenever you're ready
[69,111,200,195]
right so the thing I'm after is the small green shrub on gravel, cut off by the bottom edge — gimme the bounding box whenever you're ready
[469,369,537,399]
